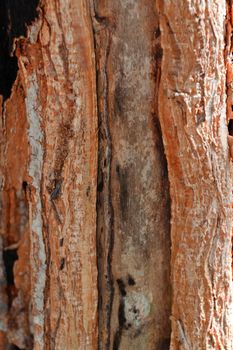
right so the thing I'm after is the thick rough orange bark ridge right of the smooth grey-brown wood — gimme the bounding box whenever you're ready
[158,1,233,349]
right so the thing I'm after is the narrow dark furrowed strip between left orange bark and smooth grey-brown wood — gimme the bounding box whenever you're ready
[92,3,114,350]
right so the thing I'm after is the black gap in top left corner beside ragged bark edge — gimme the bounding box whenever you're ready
[0,0,39,101]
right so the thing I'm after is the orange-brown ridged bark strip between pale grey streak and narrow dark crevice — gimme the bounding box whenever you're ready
[32,1,97,349]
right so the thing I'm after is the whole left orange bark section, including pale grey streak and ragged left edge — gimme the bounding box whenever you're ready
[2,1,98,349]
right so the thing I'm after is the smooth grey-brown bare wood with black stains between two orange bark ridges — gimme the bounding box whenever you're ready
[94,1,170,350]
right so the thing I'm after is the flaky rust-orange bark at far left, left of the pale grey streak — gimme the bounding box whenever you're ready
[1,74,32,348]
